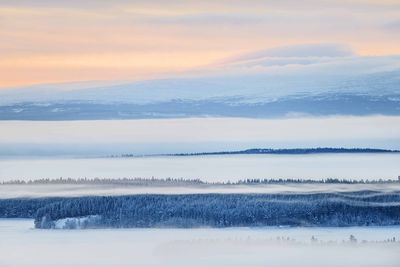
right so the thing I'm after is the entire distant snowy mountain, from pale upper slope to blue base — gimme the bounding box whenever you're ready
[0,60,400,121]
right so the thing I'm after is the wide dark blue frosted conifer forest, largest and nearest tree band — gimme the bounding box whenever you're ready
[0,191,400,228]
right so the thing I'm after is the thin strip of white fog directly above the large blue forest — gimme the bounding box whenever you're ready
[0,183,400,199]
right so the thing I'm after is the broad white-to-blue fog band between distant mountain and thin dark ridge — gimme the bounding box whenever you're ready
[0,116,400,158]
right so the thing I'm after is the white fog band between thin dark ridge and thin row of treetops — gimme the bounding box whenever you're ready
[0,154,400,181]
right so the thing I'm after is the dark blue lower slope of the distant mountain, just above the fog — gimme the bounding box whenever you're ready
[0,93,400,121]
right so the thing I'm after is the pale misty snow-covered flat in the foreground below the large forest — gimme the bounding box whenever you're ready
[0,219,400,267]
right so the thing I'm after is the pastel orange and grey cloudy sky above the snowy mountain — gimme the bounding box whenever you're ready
[0,0,400,88]
